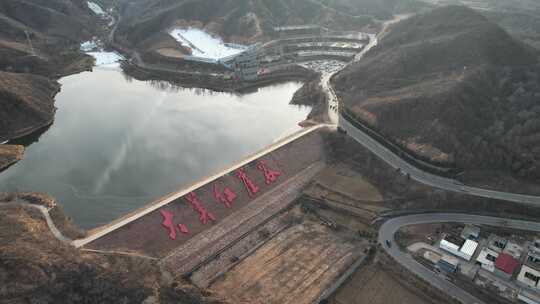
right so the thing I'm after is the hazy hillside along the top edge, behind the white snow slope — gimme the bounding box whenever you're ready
[114,0,373,46]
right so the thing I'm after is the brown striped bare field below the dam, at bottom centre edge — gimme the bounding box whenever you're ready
[211,221,363,304]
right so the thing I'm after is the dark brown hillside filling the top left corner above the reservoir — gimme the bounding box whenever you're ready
[0,0,99,76]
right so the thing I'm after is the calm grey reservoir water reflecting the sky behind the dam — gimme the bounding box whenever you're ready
[0,69,309,228]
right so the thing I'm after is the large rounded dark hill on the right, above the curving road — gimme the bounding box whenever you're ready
[333,6,540,183]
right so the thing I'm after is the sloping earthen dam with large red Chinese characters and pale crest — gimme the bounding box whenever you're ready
[72,125,335,275]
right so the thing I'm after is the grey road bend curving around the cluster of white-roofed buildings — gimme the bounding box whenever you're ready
[378,213,540,304]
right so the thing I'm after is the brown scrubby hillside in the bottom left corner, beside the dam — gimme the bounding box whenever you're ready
[0,193,228,304]
